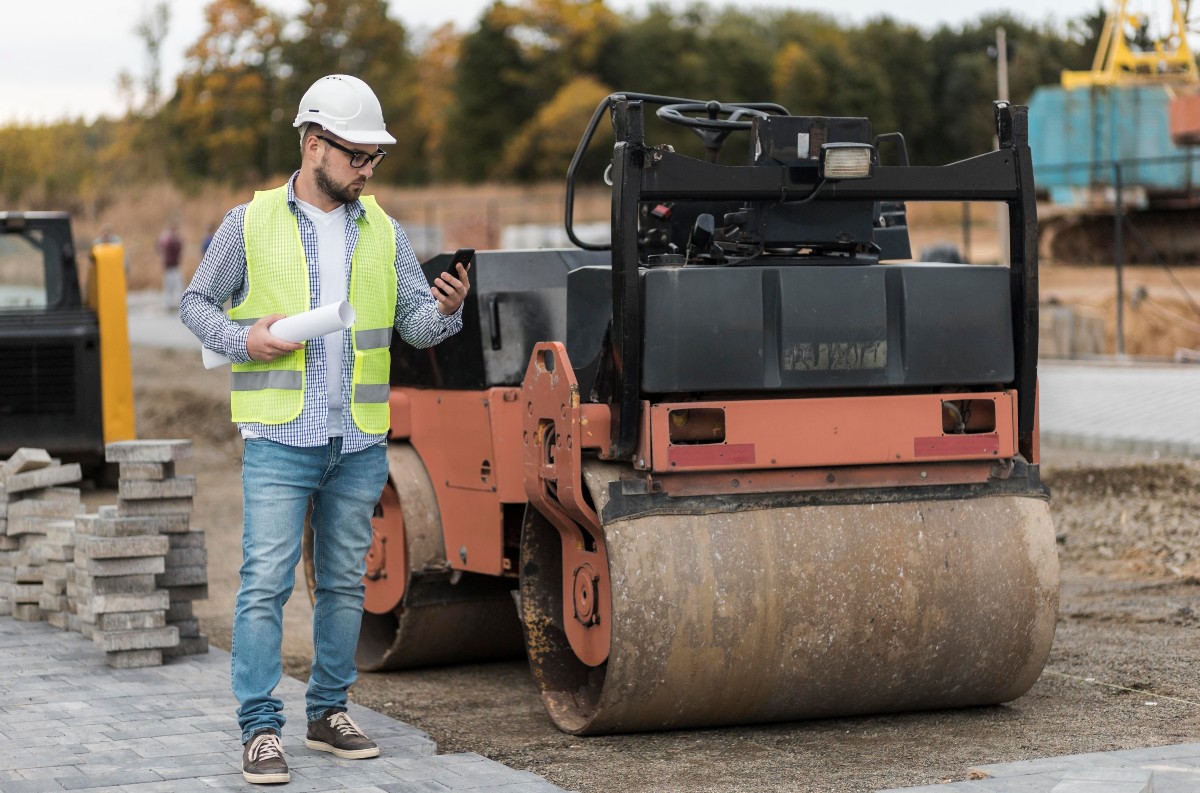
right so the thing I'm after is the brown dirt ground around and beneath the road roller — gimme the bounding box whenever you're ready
[103,333,1200,793]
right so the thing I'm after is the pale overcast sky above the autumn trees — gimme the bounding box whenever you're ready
[0,0,1123,124]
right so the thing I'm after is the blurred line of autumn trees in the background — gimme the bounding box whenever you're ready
[0,0,1104,209]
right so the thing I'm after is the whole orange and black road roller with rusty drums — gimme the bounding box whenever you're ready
[307,94,1058,735]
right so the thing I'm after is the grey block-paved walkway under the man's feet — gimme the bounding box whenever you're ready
[0,617,571,793]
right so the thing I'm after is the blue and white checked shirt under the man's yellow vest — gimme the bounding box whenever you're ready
[179,172,462,453]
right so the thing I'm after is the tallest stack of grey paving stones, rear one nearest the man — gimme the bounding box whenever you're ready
[106,440,209,657]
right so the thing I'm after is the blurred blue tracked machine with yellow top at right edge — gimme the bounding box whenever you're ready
[1030,0,1200,265]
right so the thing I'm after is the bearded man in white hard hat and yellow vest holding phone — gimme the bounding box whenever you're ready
[180,74,470,782]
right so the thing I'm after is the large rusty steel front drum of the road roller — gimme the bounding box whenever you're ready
[521,463,1058,734]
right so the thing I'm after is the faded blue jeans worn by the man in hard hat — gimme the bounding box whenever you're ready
[230,438,388,743]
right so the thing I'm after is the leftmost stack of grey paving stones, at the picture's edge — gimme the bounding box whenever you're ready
[0,449,83,627]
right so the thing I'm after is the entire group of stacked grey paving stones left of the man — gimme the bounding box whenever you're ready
[0,440,209,668]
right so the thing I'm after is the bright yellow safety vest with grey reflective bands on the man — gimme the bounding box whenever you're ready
[229,185,396,434]
